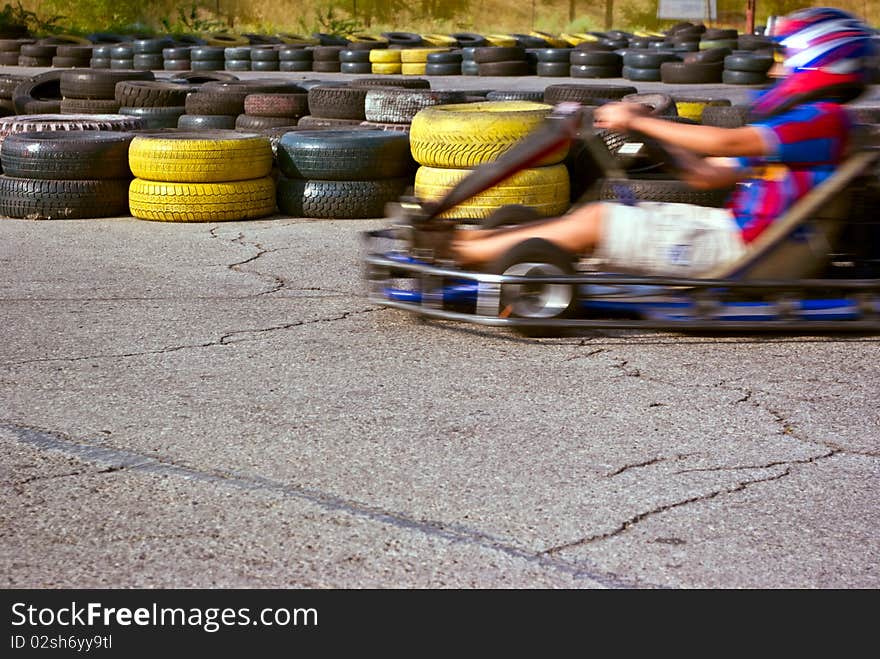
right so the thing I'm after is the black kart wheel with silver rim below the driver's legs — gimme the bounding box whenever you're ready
[488,238,576,337]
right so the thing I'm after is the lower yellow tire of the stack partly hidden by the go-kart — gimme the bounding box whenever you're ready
[413,165,570,219]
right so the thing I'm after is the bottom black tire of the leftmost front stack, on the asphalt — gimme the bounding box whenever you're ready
[0,176,129,220]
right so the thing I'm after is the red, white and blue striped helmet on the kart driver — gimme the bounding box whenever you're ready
[752,7,874,117]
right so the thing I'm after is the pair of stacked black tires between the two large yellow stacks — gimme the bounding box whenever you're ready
[277,128,415,219]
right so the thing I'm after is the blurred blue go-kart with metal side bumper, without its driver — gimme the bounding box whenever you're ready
[363,104,880,336]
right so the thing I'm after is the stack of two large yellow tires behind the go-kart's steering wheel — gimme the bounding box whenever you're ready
[410,101,570,220]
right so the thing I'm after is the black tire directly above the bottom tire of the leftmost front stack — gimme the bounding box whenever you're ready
[0,130,134,180]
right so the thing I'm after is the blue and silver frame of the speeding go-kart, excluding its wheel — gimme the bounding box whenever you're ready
[362,104,880,336]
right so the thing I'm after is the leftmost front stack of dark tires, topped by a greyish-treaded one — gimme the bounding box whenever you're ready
[0,115,139,220]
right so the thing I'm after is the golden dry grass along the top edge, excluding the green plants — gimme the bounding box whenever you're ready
[12,0,880,34]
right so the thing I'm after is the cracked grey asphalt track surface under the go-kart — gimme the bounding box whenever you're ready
[0,71,880,589]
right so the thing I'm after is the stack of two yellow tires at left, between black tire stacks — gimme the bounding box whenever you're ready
[128,130,275,222]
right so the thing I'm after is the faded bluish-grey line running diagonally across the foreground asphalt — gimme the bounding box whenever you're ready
[0,420,662,589]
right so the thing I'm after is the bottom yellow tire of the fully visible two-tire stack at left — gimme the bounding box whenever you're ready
[128,176,275,222]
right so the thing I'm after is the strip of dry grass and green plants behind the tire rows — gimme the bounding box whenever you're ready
[8,0,880,34]
